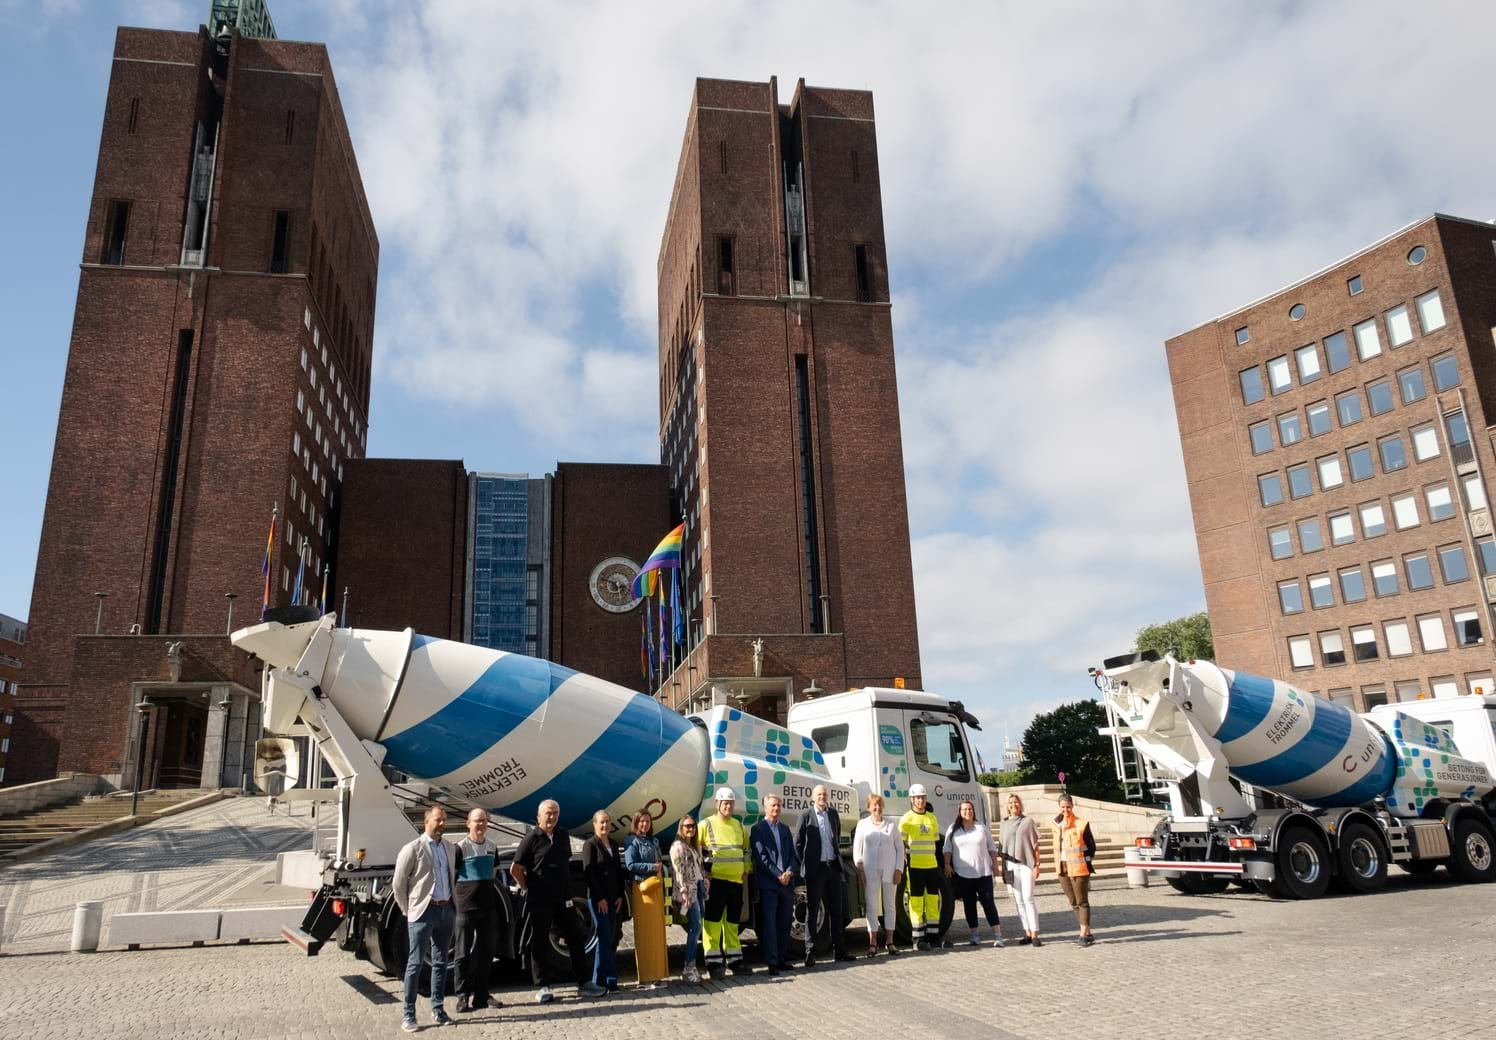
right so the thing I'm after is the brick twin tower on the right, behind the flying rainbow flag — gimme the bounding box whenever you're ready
[660,79,920,717]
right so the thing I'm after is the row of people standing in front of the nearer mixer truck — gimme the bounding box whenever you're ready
[393,784,1095,1033]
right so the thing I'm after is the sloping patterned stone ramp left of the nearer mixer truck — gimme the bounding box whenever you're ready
[0,798,311,951]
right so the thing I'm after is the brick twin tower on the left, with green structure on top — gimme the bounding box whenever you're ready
[6,0,378,786]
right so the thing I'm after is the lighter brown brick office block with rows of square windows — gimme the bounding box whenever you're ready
[1167,214,1496,709]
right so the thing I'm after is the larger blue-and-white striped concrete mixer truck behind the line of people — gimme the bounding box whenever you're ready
[232,615,987,974]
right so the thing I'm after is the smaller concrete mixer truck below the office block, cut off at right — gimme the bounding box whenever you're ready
[1092,651,1496,899]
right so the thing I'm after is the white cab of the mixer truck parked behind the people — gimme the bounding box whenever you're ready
[788,687,987,828]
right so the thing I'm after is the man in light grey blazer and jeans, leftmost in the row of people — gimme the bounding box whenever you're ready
[392,805,458,1033]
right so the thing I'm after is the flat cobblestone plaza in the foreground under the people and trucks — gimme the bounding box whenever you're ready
[0,871,1496,1040]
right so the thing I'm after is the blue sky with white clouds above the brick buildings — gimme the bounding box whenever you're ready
[0,0,1496,759]
